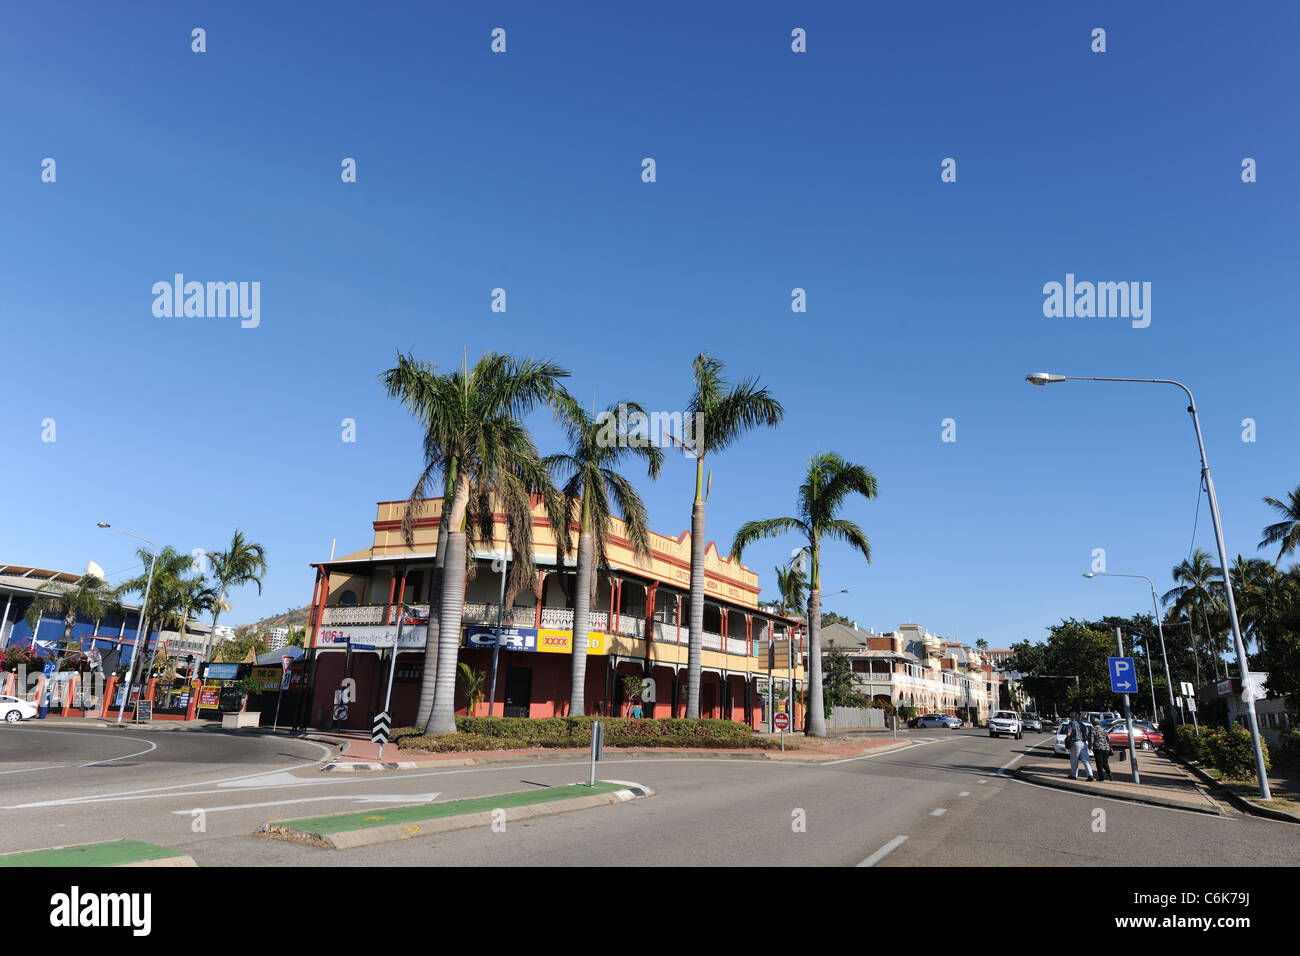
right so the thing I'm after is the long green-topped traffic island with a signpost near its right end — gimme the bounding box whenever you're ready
[256,780,654,849]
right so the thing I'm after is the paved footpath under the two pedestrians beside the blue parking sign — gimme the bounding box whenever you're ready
[1008,744,1223,816]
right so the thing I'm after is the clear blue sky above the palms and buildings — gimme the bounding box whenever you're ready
[0,3,1300,646]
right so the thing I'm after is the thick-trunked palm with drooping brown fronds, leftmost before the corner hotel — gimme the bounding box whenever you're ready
[382,352,568,734]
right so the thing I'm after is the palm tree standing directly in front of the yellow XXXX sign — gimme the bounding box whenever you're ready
[546,399,663,717]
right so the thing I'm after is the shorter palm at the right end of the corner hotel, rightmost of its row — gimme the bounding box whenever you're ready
[732,451,876,737]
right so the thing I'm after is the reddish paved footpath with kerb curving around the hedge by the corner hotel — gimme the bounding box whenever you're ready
[309,731,911,773]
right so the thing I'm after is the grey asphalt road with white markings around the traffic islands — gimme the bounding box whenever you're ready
[0,724,1300,866]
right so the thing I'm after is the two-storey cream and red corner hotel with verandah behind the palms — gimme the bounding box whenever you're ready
[303,498,803,730]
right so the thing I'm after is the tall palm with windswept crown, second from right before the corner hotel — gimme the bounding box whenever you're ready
[680,352,785,719]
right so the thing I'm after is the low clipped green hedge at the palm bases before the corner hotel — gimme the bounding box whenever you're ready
[393,717,792,752]
